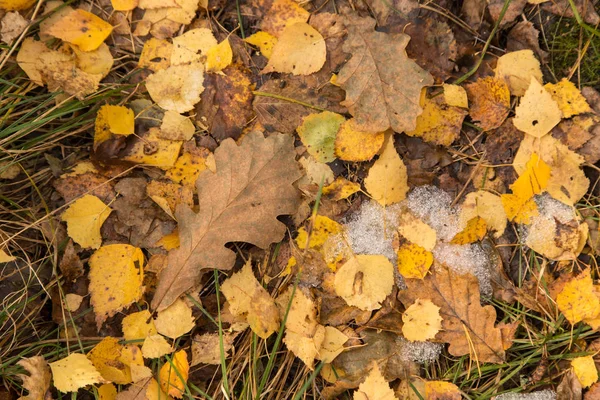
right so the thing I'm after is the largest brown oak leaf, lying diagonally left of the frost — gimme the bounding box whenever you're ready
[152,132,300,310]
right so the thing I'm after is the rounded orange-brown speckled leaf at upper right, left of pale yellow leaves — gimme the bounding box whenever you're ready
[465,77,510,131]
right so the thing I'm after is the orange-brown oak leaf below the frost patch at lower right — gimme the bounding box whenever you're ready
[398,264,505,363]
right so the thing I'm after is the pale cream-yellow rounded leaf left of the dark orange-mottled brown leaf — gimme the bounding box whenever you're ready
[146,62,204,114]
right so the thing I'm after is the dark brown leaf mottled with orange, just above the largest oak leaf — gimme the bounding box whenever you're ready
[196,65,253,141]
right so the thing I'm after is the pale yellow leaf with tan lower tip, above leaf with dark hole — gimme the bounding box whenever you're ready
[496,50,543,96]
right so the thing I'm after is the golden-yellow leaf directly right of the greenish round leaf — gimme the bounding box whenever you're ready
[335,119,385,161]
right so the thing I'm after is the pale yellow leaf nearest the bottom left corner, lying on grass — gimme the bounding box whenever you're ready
[50,353,103,393]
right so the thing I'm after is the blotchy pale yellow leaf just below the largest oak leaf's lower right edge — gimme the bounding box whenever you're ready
[221,260,280,339]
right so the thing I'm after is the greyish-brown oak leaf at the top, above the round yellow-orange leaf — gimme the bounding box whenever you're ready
[337,17,433,132]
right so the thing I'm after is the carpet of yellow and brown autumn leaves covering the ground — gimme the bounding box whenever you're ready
[0,0,600,400]
